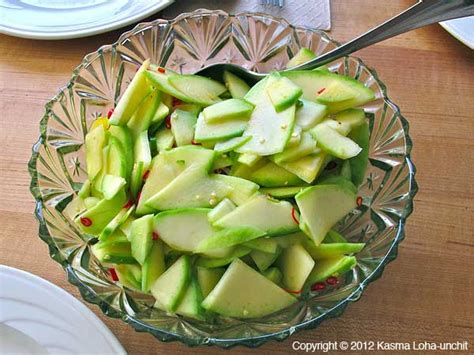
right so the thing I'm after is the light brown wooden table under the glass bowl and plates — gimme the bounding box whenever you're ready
[0,0,474,354]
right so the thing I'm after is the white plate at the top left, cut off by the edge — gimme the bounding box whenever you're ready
[0,0,174,39]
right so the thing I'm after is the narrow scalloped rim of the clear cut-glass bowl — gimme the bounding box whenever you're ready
[28,9,418,348]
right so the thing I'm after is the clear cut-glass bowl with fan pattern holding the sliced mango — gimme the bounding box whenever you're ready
[29,10,417,348]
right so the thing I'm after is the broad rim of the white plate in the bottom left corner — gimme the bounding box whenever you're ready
[0,265,126,354]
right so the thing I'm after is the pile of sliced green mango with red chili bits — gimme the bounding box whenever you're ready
[65,49,374,320]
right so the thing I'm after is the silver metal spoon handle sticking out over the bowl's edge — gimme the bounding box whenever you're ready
[290,0,474,71]
